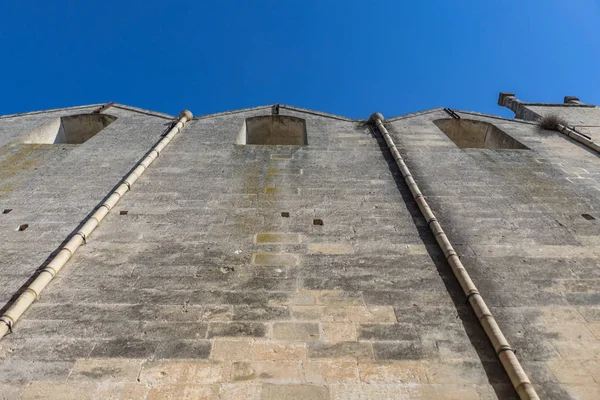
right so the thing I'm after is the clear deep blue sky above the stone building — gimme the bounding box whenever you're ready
[0,0,600,118]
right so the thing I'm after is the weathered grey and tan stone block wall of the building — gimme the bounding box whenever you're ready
[0,97,600,400]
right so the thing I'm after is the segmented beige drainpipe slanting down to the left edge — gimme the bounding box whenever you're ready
[0,110,192,339]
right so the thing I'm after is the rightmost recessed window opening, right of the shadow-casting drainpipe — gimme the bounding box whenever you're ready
[433,118,528,150]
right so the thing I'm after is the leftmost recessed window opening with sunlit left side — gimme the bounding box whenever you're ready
[22,114,117,144]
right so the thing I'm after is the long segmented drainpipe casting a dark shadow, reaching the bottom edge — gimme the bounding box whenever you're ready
[369,113,539,400]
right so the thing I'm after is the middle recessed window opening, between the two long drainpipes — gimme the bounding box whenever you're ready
[237,115,307,146]
